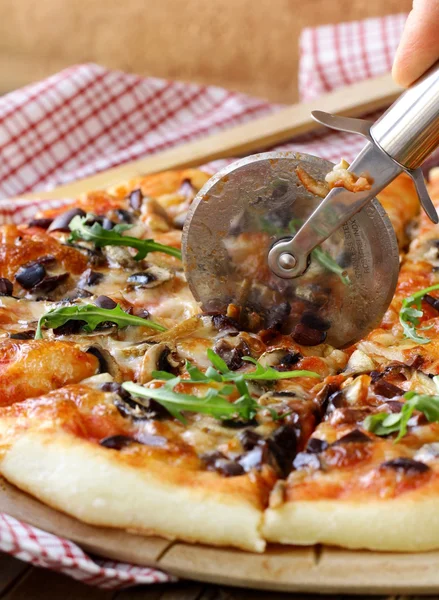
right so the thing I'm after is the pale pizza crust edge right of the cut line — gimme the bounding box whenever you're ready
[262,495,439,552]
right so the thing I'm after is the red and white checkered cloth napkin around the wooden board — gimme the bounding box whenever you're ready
[0,14,412,588]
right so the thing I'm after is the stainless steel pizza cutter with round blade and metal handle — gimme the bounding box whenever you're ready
[182,65,439,348]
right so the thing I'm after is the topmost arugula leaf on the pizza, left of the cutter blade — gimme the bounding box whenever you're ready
[69,215,181,260]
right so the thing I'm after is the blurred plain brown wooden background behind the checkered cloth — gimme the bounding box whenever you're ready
[0,0,411,102]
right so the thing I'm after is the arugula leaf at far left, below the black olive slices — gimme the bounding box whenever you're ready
[35,304,166,340]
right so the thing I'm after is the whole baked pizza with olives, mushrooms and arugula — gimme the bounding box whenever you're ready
[0,164,439,552]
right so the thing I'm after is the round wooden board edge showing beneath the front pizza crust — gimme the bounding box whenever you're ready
[0,479,439,594]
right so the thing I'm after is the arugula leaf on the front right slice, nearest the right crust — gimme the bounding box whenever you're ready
[363,392,439,443]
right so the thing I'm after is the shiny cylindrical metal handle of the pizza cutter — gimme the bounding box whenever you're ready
[370,63,439,169]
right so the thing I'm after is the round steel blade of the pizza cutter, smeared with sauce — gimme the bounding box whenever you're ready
[183,152,399,347]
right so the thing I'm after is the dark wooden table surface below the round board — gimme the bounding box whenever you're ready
[0,554,439,600]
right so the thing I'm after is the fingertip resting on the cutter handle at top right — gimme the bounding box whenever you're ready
[392,0,439,87]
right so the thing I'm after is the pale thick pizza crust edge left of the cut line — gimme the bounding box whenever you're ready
[0,431,265,552]
